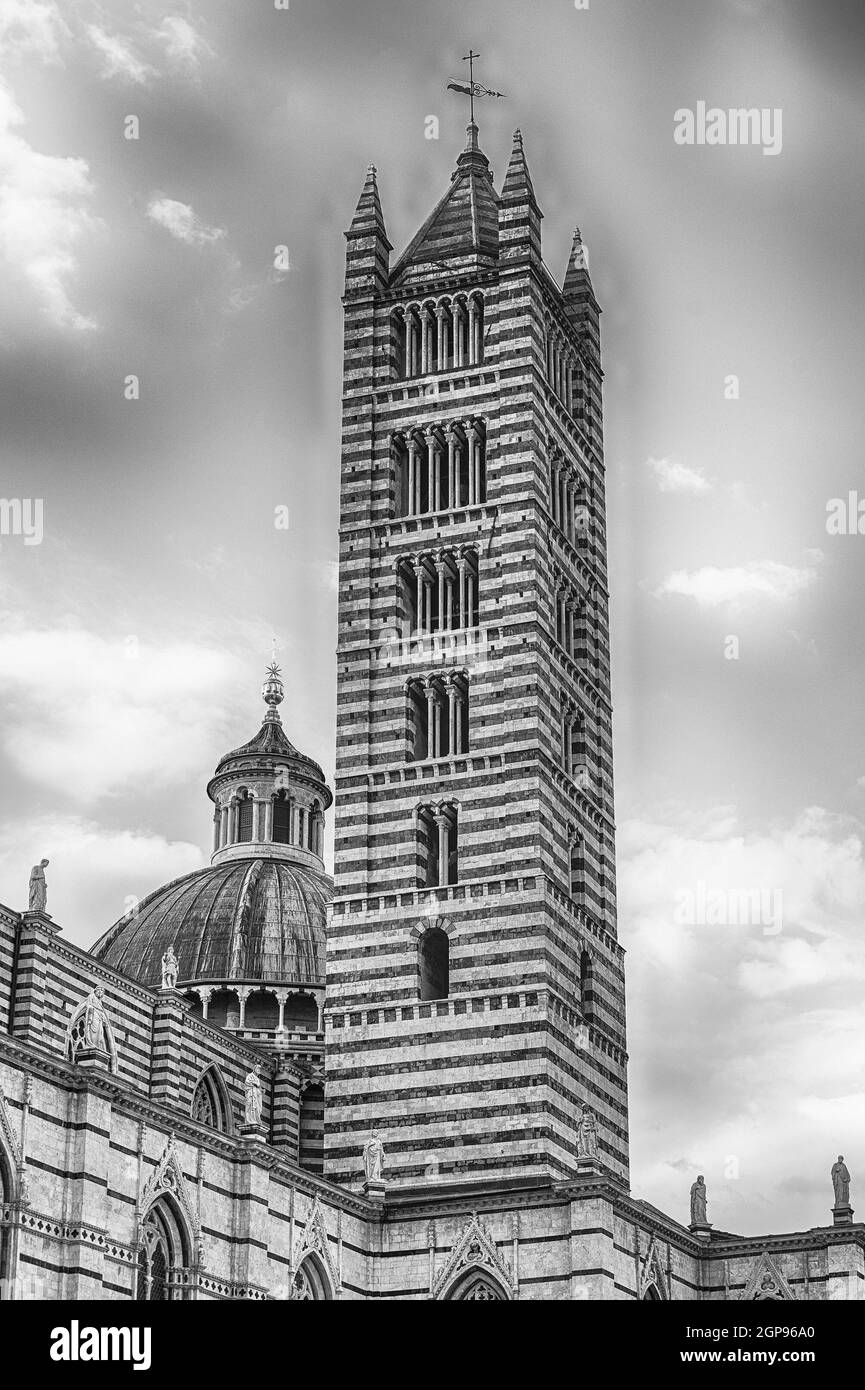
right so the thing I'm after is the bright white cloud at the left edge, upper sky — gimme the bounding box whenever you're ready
[0,85,102,331]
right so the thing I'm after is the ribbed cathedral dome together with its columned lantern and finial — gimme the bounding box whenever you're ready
[93,663,334,1013]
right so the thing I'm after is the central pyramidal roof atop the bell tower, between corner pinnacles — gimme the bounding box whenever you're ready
[391,121,499,285]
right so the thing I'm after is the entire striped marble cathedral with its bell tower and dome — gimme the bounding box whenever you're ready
[0,122,865,1301]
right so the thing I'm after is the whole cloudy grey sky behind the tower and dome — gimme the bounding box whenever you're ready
[0,0,865,1233]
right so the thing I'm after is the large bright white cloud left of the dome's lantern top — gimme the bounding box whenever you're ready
[0,628,247,803]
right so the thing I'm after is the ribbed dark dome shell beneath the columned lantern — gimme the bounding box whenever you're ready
[92,856,331,988]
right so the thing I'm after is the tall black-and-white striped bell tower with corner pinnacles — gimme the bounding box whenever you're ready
[325,122,629,1188]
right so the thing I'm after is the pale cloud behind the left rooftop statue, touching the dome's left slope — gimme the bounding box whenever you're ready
[0,815,206,947]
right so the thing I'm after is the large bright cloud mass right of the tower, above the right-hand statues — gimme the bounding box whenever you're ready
[617,806,865,1233]
